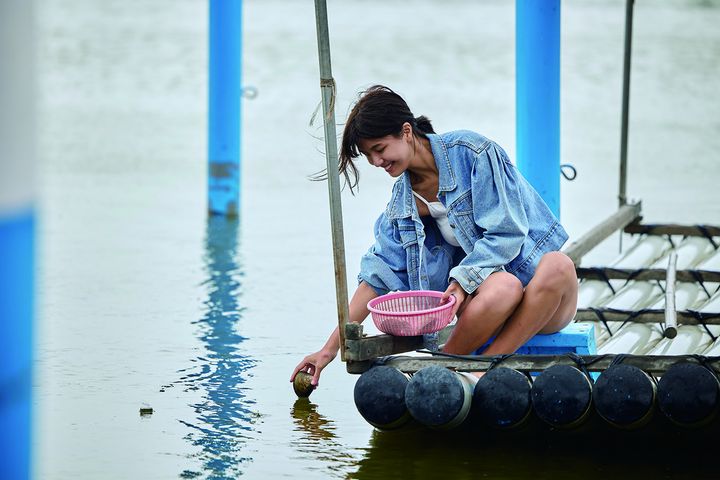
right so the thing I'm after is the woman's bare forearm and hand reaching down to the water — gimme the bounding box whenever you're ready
[290,282,377,386]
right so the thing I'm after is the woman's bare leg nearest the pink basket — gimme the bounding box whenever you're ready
[443,272,523,355]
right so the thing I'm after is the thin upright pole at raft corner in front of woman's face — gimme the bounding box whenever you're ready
[315,0,349,361]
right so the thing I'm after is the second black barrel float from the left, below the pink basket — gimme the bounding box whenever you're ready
[405,365,474,428]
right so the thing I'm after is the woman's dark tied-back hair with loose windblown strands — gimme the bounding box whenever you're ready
[311,85,435,193]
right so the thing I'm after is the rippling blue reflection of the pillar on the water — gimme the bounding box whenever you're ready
[163,217,255,479]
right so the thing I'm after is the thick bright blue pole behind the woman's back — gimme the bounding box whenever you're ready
[515,0,560,218]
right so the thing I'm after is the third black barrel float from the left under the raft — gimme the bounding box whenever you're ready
[473,367,531,428]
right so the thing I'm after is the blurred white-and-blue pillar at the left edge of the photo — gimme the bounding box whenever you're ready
[0,0,36,480]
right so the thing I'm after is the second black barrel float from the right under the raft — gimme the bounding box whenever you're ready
[593,365,656,429]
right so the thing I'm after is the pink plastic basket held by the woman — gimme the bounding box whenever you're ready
[368,290,455,337]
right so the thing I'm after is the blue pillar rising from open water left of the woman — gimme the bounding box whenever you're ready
[208,0,242,217]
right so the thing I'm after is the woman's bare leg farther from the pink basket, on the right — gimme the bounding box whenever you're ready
[483,252,578,355]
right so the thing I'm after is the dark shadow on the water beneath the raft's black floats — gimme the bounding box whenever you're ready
[347,416,717,480]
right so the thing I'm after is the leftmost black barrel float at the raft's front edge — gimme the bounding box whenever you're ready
[354,365,410,430]
